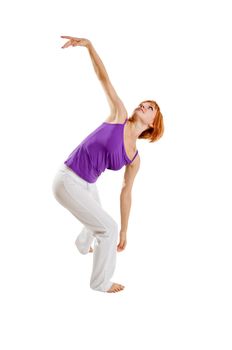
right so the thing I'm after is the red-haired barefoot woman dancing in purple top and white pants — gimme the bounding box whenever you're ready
[53,36,164,293]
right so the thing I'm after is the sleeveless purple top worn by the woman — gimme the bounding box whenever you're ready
[64,118,138,183]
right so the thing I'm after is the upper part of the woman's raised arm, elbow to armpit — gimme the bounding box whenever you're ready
[100,78,128,119]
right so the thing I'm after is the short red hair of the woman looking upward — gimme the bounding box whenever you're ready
[135,100,164,143]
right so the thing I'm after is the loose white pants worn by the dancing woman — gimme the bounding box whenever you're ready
[52,164,118,292]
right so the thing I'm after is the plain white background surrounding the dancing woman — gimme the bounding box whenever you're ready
[0,0,232,350]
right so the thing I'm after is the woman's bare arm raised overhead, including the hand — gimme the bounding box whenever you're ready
[61,36,127,117]
